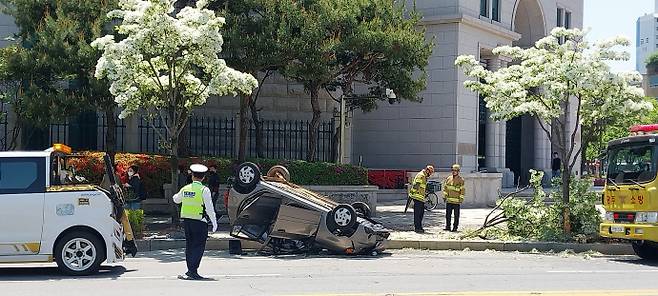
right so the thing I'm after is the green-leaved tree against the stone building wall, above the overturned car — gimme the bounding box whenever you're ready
[283,0,433,161]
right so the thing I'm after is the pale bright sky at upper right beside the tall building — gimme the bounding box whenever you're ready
[583,0,655,71]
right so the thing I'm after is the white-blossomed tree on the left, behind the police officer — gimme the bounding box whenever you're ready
[92,0,258,190]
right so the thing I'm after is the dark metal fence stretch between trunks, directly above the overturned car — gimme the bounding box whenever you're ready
[247,119,336,162]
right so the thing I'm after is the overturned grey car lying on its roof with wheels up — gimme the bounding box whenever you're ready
[225,162,389,254]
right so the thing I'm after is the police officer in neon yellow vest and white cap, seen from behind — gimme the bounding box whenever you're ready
[173,164,217,280]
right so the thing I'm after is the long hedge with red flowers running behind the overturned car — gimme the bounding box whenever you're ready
[71,152,368,198]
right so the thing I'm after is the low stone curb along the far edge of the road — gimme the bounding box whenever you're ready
[137,238,635,255]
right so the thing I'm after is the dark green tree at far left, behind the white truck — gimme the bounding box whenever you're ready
[0,0,117,155]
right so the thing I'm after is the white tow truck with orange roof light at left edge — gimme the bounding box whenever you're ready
[0,144,137,275]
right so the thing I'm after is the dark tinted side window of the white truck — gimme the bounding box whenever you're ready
[0,158,46,194]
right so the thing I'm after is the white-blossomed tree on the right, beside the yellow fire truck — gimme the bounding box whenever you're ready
[455,28,652,234]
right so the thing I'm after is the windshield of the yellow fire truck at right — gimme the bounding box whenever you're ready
[608,143,658,184]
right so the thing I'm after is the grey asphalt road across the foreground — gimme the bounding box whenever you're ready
[0,250,658,296]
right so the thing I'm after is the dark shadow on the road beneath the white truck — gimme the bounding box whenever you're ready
[0,266,135,282]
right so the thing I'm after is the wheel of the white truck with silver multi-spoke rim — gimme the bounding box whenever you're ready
[54,231,105,276]
